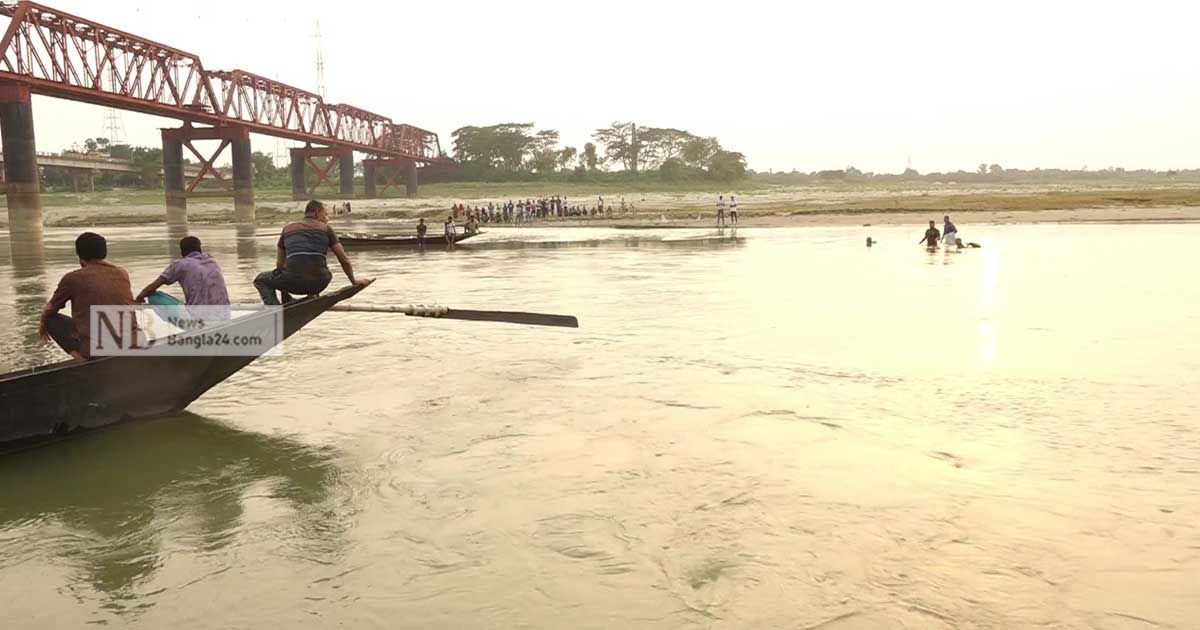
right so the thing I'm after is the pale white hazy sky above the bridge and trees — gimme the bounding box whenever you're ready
[18,0,1200,172]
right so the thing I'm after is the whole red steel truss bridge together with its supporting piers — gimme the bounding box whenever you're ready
[0,1,440,228]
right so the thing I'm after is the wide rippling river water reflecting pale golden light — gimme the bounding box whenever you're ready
[0,224,1200,630]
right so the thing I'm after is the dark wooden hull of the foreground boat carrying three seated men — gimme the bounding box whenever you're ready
[0,286,364,450]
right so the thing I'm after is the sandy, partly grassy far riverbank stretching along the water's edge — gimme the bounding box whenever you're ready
[0,186,1200,227]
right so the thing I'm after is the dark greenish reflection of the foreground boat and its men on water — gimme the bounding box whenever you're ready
[0,414,348,612]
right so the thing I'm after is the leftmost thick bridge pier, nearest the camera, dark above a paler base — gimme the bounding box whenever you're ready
[0,82,42,242]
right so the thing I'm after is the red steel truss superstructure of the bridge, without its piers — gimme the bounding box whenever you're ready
[0,1,440,162]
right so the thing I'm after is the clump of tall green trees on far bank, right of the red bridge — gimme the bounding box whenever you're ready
[450,121,746,181]
